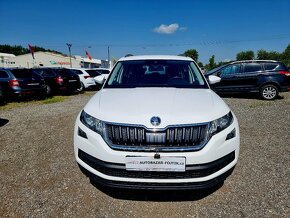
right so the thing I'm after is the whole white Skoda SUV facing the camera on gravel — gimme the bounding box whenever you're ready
[74,56,240,189]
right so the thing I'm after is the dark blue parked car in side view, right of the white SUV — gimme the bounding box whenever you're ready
[207,60,290,100]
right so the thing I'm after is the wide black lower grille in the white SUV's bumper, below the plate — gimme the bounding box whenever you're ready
[78,150,235,179]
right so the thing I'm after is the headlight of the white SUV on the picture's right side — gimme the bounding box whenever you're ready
[208,112,233,138]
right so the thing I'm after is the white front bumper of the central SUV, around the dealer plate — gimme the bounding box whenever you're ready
[74,112,240,189]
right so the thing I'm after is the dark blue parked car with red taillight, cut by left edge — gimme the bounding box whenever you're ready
[0,68,46,100]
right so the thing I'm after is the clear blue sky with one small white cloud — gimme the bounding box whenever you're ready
[0,0,290,63]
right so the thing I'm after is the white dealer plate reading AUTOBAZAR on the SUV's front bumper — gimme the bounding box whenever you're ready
[126,156,185,172]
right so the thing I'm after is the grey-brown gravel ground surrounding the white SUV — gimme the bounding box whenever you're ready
[0,93,290,218]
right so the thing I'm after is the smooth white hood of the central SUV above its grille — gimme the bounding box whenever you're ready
[84,88,230,128]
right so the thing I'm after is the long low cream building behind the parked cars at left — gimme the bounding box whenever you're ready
[5,51,102,68]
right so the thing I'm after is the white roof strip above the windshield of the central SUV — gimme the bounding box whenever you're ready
[119,55,193,61]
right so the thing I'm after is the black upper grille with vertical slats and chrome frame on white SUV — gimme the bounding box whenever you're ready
[106,124,208,151]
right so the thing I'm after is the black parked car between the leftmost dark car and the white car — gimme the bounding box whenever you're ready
[50,68,82,94]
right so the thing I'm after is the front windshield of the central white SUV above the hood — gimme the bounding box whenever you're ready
[104,60,208,88]
